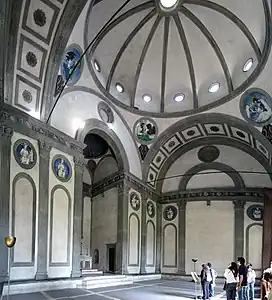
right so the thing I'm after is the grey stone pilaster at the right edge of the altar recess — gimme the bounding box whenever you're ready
[116,182,128,274]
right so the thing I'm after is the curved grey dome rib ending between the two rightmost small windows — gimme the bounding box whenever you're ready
[180,6,233,93]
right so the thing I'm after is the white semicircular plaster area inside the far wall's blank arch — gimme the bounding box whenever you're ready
[187,170,234,190]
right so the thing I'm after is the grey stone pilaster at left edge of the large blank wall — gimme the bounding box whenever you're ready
[177,201,187,275]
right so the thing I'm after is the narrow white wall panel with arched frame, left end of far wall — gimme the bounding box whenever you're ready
[161,204,179,273]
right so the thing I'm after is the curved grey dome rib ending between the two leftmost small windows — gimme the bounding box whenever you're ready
[106,8,156,91]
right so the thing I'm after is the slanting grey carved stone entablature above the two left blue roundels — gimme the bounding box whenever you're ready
[0,104,84,156]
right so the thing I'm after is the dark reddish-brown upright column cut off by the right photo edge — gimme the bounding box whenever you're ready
[262,191,272,270]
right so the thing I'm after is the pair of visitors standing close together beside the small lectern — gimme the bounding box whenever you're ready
[200,263,217,300]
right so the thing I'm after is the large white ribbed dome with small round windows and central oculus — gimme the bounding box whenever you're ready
[85,0,271,117]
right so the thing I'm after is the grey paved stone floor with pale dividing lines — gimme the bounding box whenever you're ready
[3,280,260,300]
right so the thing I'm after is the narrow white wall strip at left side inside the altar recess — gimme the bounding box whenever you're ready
[82,197,92,260]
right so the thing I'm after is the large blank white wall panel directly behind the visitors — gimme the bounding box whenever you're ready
[185,201,234,276]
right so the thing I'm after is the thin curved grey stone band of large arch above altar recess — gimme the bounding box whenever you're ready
[62,86,141,165]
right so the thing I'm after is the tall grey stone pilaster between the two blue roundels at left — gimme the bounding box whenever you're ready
[35,141,52,280]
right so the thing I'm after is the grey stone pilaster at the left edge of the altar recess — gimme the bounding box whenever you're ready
[71,156,84,277]
